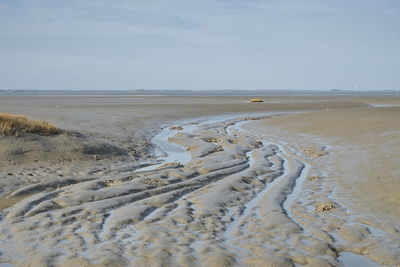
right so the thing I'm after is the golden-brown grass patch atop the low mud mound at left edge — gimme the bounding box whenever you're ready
[0,113,60,136]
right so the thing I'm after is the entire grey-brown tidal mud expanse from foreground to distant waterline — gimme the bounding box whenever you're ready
[0,96,400,266]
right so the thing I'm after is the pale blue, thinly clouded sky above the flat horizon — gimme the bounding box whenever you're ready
[0,0,400,90]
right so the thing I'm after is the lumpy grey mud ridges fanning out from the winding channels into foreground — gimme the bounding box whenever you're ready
[0,118,399,266]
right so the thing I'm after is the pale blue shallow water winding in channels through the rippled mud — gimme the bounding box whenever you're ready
[136,113,379,267]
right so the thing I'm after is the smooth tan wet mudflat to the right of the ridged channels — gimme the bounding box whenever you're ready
[244,107,400,266]
